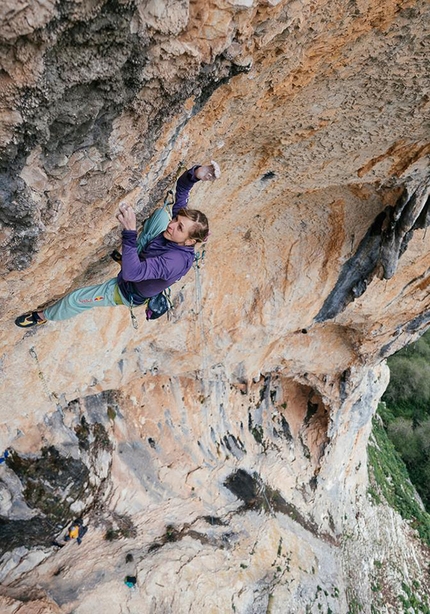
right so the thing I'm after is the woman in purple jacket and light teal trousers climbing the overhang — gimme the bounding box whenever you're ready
[15,161,220,328]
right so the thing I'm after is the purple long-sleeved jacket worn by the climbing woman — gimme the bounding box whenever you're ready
[117,166,199,305]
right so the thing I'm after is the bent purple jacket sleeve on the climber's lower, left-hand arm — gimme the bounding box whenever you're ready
[121,230,182,281]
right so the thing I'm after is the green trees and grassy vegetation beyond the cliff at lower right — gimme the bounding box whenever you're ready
[368,331,430,614]
